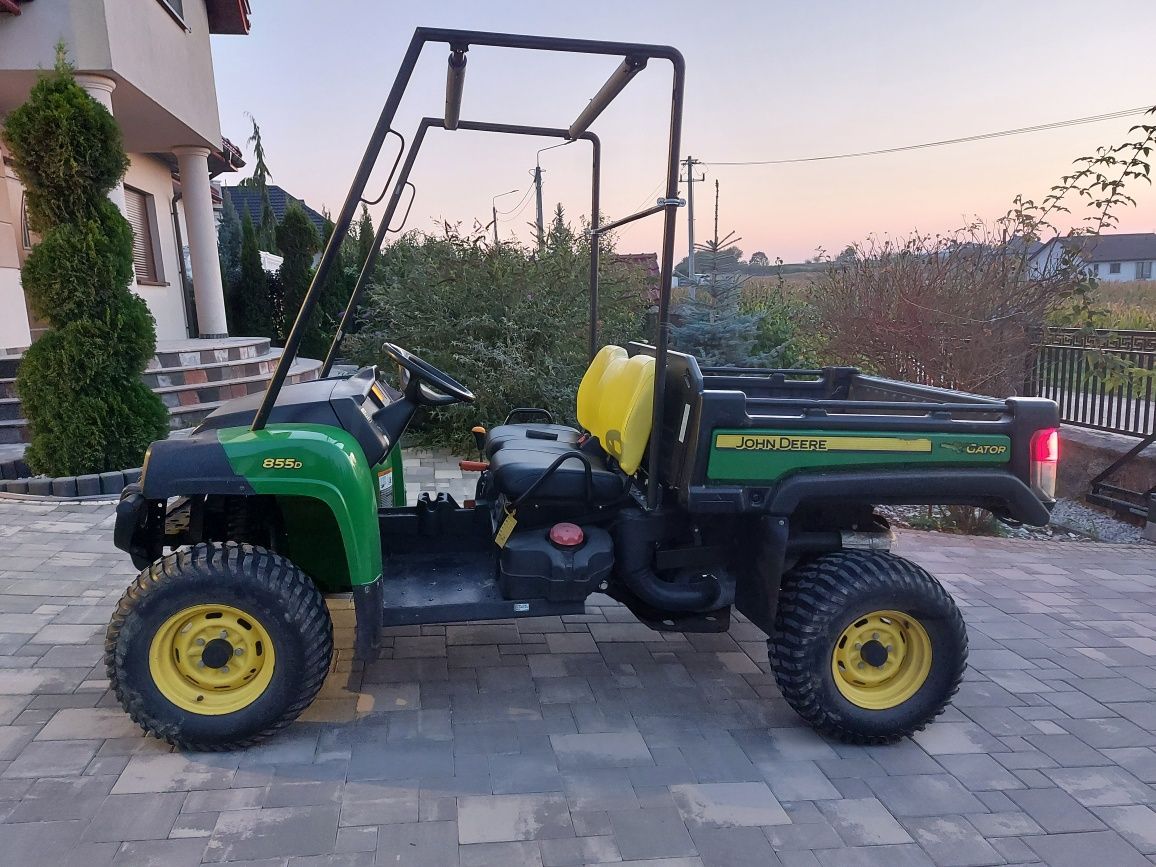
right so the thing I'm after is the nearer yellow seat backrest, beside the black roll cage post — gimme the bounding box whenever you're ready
[586,355,654,475]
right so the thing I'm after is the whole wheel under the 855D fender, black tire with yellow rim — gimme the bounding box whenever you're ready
[104,542,333,751]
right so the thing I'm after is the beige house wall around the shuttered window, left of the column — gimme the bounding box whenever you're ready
[125,154,188,340]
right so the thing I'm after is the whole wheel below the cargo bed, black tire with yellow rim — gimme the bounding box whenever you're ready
[768,551,968,743]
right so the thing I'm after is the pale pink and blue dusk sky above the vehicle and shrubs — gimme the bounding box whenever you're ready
[213,0,1156,261]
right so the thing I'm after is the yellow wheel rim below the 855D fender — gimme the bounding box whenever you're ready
[148,605,275,717]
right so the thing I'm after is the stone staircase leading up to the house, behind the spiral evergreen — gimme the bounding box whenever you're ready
[0,338,321,444]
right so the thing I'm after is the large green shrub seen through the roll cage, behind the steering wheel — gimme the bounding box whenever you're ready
[346,221,647,453]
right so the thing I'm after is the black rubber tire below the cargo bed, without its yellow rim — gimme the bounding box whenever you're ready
[766,551,968,743]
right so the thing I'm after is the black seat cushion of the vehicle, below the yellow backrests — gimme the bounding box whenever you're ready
[490,444,628,504]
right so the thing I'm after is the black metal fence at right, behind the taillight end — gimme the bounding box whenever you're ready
[1028,328,1156,437]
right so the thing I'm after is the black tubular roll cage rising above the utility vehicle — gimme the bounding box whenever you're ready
[251,28,686,509]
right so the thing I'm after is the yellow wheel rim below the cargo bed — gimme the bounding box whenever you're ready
[831,610,932,711]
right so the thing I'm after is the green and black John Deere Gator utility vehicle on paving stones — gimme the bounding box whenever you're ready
[105,29,1058,750]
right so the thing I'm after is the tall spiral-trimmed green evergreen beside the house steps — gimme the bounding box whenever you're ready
[3,57,168,476]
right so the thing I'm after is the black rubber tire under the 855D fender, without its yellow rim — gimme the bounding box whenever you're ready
[104,542,333,751]
